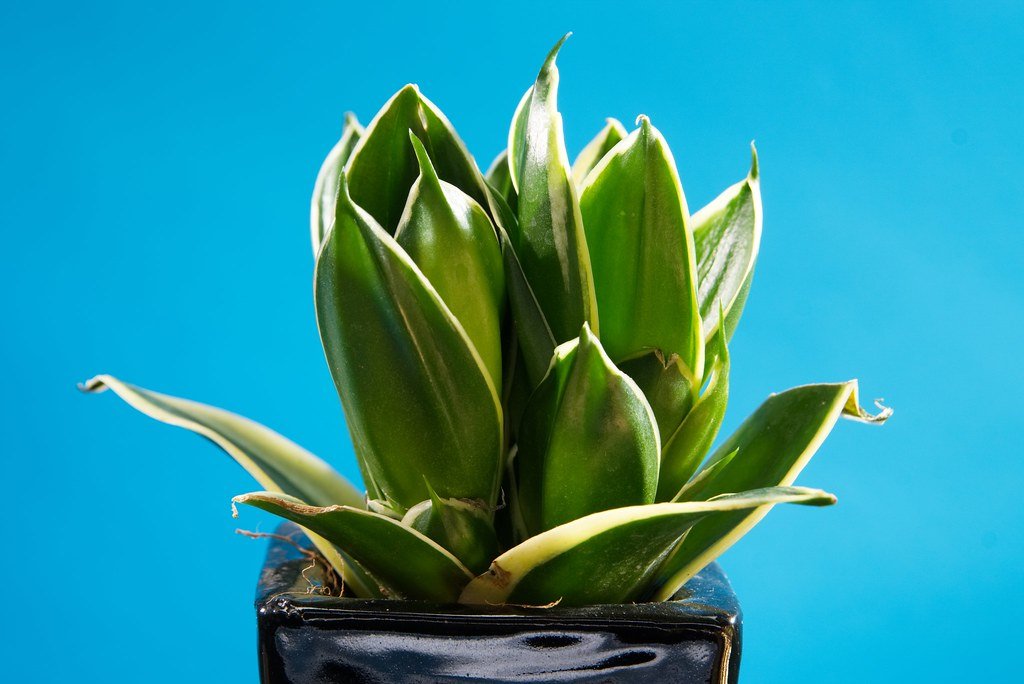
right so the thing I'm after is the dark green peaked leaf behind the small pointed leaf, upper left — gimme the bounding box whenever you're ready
[345,85,489,233]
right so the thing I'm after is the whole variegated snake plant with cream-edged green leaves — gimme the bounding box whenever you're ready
[83,39,891,605]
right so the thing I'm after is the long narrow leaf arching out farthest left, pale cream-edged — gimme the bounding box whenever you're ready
[80,375,377,596]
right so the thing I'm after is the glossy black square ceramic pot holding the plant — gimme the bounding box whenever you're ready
[256,523,741,684]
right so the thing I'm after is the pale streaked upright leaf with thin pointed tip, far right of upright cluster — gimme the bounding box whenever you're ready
[691,143,763,340]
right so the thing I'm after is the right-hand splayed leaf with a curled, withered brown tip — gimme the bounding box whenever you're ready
[657,380,892,599]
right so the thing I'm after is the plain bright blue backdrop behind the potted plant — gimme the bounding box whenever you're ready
[0,2,1024,683]
